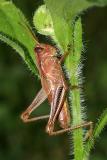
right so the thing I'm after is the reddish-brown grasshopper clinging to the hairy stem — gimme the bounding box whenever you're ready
[21,23,92,135]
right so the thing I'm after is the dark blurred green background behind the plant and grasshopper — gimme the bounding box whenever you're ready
[0,0,107,160]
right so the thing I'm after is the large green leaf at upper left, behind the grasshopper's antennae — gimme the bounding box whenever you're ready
[0,0,37,74]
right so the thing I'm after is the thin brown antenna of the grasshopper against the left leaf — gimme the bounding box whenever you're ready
[18,22,39,44]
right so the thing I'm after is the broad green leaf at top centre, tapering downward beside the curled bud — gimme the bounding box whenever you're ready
[44,0,107,51]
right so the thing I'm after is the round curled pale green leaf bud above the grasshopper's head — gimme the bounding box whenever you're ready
[33,5,62,50]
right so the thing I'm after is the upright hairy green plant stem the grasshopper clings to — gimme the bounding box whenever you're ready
[66,18,84,160]
